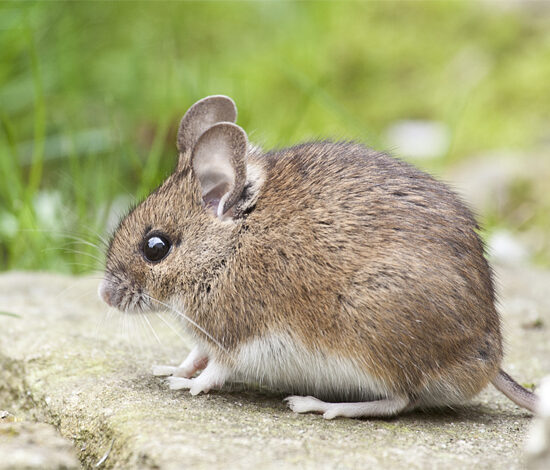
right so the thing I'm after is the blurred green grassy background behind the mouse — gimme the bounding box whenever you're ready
[0,1,550,273]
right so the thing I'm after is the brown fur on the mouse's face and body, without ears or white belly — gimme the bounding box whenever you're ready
[102,131,502,403]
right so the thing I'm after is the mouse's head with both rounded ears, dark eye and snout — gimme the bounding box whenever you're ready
[99,96,262,312]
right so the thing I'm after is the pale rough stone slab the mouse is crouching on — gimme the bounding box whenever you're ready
[0,268,550,469]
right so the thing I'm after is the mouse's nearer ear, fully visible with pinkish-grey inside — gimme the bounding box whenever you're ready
[191,122,248,219]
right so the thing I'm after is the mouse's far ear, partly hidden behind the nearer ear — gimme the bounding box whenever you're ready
[177,95,237,158]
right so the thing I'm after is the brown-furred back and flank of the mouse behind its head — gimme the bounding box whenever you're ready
[189,142,502,404]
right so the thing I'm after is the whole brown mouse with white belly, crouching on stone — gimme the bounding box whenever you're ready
[99,95,538,419]
